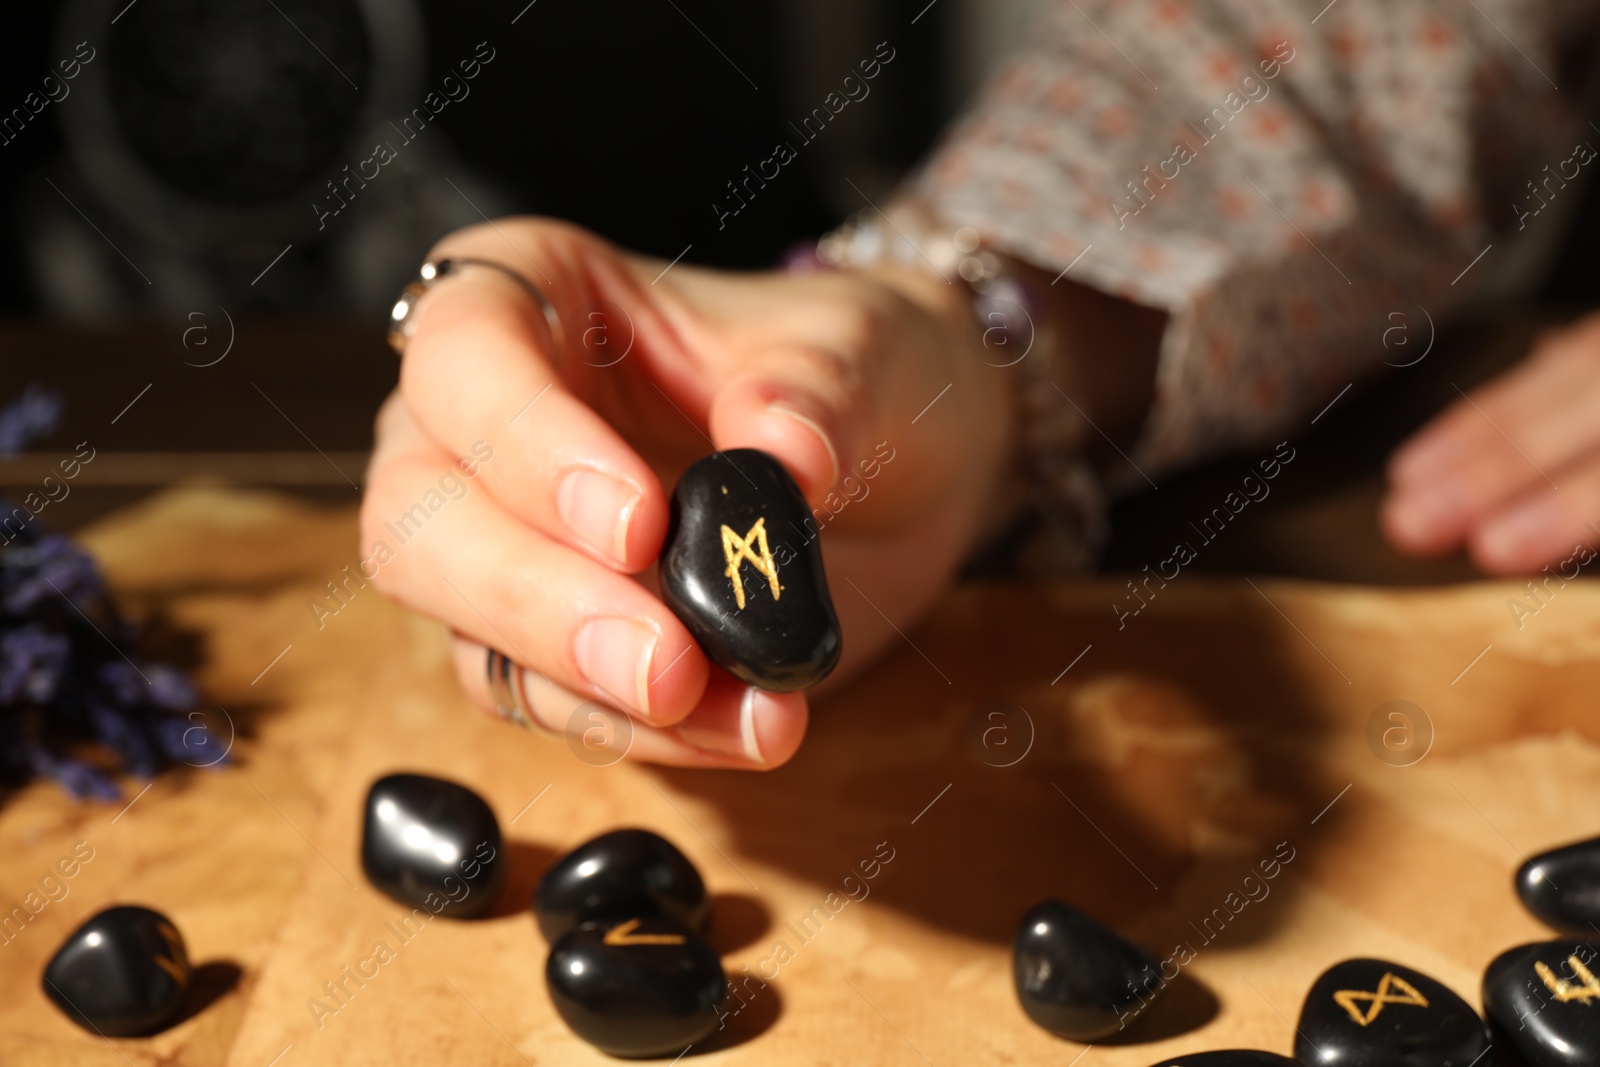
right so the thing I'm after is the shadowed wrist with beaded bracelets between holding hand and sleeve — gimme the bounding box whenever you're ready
[803,200,1100,569]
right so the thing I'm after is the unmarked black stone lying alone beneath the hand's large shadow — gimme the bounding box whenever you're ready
[1011,901,1165,1041]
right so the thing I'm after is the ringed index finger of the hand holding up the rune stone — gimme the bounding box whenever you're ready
[400,221,667,573]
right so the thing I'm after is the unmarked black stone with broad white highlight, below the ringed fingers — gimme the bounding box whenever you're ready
[362,774,506,918]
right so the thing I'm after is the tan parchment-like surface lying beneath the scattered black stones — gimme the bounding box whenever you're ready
[0,489,1600,1067]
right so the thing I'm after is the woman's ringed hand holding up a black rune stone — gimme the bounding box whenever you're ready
[362,219,1013,768]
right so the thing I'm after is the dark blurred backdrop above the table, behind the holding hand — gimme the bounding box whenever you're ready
[0,0,998,322]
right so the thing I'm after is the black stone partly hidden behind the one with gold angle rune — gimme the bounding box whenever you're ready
[533,830,710,945]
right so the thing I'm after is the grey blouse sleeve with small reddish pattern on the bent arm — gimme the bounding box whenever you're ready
[906,0,1600,486]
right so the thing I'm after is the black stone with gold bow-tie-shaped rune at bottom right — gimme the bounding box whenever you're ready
[1294,960,1493,1067]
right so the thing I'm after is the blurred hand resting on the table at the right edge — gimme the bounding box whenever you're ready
[1382,315,1600,574]
